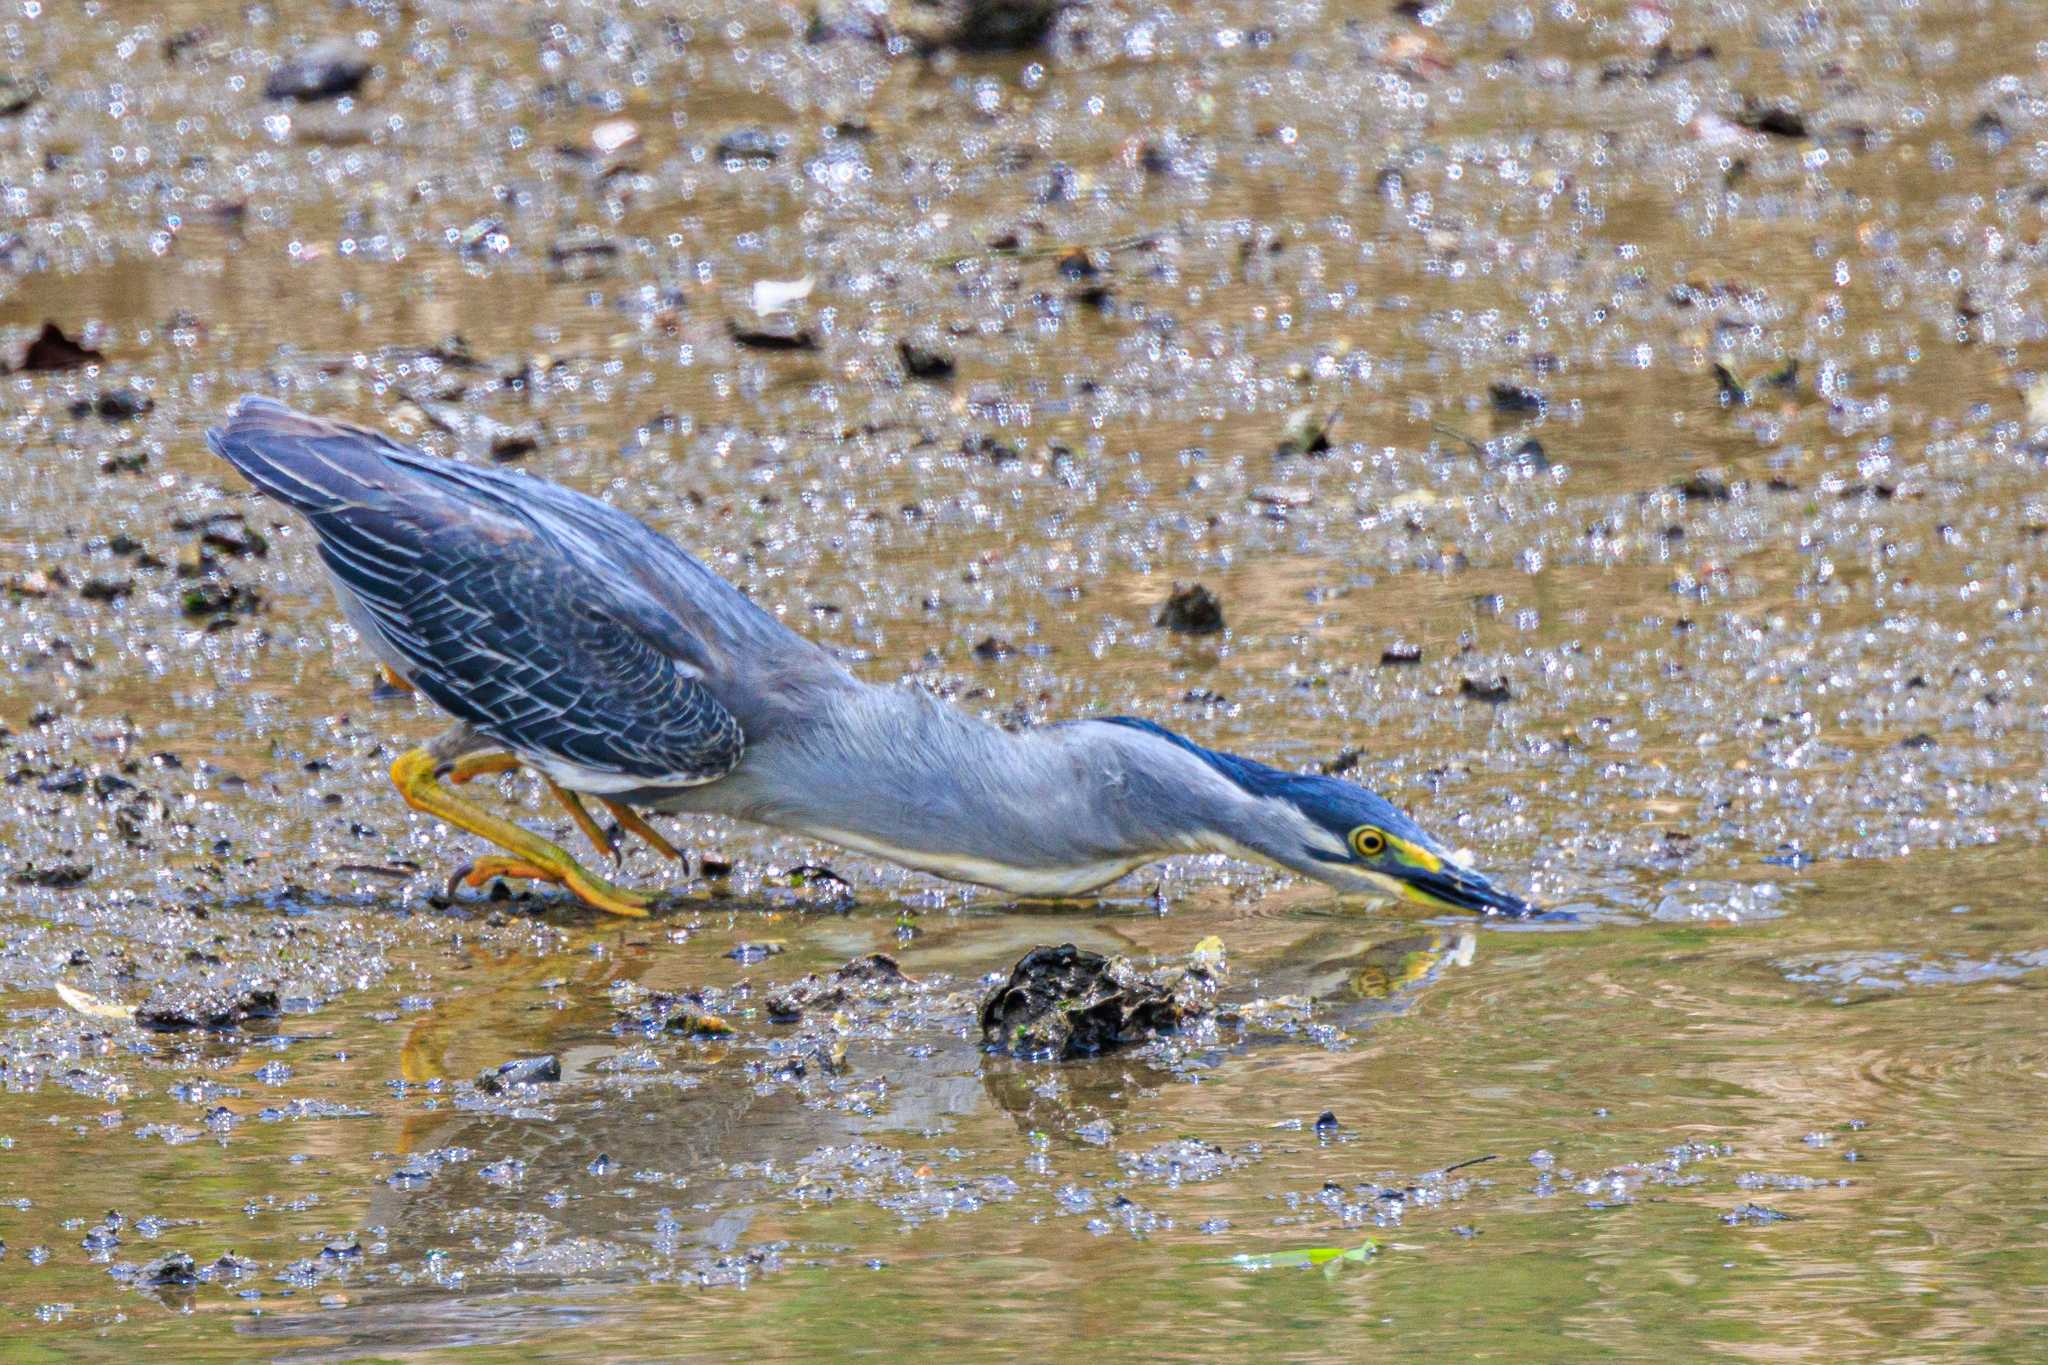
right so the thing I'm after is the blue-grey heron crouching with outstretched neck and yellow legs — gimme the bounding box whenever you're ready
[207,397,1534,917]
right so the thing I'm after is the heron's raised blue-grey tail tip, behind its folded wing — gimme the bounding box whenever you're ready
[207,395,406,516]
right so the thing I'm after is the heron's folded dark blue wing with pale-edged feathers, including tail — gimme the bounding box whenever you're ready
[209,394,745,792]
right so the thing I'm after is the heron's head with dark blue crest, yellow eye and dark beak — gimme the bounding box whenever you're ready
[1112,716,1538,919]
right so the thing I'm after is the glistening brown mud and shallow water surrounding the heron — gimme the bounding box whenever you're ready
[0,0,2048,1359]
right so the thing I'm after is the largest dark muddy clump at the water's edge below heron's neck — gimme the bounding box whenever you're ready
[981,943,1212,1062]
